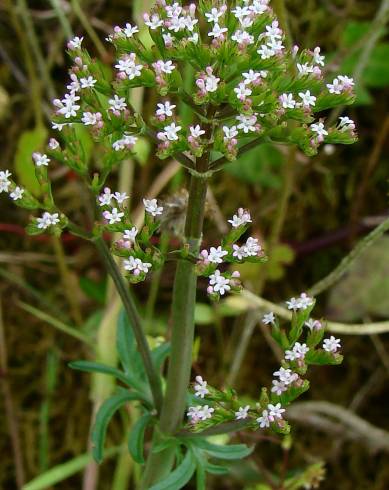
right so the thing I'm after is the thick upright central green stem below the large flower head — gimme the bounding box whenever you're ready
[142,160,209,489]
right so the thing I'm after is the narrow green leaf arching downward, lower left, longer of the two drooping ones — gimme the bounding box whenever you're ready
[92,391,140,463]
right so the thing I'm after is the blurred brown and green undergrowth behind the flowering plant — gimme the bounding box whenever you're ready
[0,0,389,490]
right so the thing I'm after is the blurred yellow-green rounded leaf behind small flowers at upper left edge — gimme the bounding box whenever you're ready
[14,126,47,197]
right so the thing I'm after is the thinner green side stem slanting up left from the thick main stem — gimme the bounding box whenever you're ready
[93,237,163,412]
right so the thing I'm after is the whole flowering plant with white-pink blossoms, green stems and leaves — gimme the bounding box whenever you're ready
[0,0,356,490]
